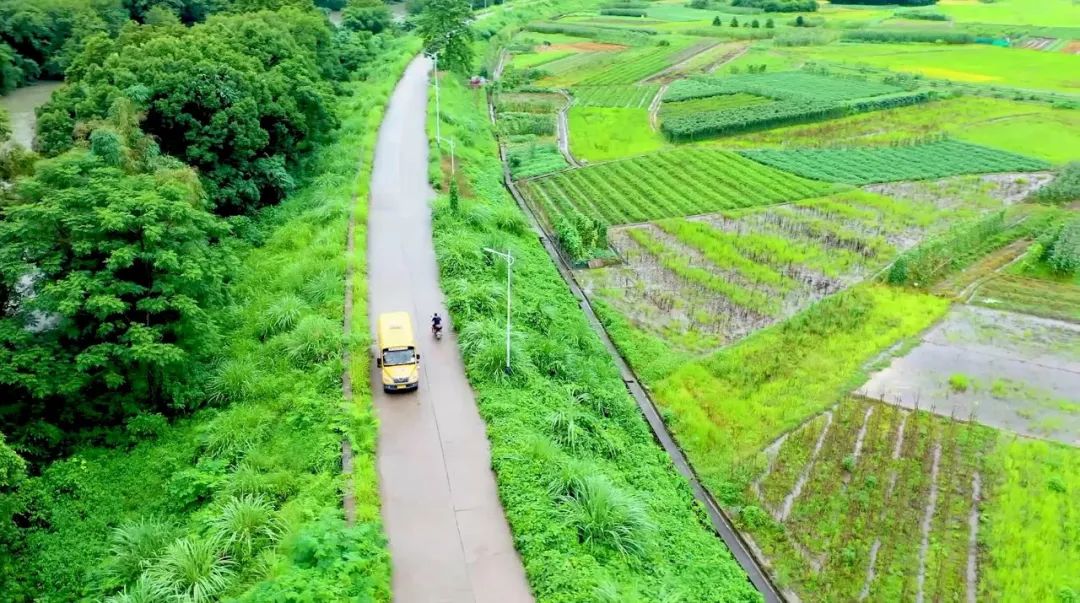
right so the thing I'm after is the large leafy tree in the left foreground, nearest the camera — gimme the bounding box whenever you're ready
[0,118,232,458]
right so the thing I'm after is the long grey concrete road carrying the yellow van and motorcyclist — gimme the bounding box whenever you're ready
[367,57,532,603]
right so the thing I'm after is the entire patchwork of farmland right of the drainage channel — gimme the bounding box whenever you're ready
[492,0,1080,602]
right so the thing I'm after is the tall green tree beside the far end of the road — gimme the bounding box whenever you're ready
[417,0,473,75]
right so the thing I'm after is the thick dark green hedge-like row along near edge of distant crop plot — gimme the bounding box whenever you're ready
[661,92,932,140]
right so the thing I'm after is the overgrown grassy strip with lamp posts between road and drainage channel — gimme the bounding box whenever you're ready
[429,56,759,601]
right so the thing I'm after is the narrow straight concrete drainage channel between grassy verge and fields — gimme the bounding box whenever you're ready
[488,137,787,603]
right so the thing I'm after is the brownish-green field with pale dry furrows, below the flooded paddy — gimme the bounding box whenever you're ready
[755,400,994,601]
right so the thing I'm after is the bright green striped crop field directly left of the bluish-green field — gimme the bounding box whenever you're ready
[526,149,828,224]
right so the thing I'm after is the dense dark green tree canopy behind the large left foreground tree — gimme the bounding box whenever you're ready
[39,9,341,214]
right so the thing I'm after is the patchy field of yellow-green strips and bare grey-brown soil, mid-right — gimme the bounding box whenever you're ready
[579,190,1001,352]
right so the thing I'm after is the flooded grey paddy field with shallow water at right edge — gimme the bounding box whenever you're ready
[859,306,1080,445]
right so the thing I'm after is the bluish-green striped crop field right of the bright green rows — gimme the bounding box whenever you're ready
[742,140,1050,185]
